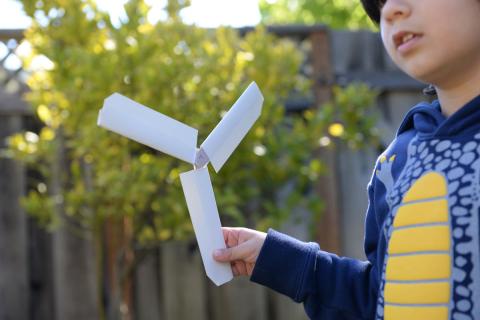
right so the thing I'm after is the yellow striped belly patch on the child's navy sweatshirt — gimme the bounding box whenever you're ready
[384,172,452,320]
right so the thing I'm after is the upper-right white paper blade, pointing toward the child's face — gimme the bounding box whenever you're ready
[200,82,263,172]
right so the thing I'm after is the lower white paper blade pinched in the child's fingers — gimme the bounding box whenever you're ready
[180,168,233,286]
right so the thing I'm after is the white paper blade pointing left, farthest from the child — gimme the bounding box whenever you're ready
[97,93,198,164]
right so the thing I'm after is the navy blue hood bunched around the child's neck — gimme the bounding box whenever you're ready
[397,92,480,139]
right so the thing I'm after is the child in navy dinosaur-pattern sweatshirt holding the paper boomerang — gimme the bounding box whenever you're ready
[214,0,480,320]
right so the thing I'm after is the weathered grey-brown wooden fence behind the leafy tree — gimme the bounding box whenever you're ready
[0,26,424,320]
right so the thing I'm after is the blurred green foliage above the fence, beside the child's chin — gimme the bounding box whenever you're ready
[259,0,375,29]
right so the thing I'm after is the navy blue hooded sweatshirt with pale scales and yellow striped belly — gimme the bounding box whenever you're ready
[251,96,480,320]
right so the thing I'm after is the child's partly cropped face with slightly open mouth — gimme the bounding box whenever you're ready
[380,0,480,86]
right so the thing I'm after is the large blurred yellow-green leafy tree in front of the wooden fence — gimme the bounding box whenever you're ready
[10,0,373,319]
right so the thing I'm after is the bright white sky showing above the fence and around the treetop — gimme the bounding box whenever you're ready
[0,0,260,29]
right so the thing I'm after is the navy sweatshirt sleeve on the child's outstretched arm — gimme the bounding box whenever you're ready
[251,184,380,320]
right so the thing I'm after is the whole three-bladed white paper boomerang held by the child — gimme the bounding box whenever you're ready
[97,82,263,286]
